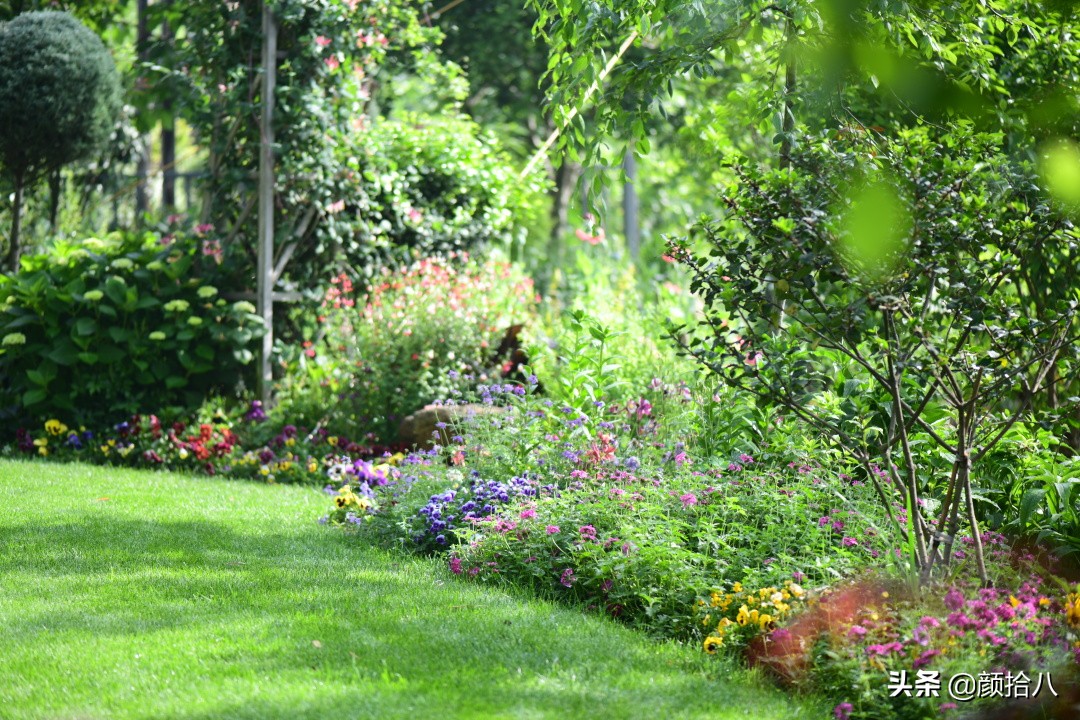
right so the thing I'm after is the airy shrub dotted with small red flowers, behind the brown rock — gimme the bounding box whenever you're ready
[283,255,535,441]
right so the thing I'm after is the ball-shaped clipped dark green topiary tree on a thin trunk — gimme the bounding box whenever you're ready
[0,12,120,272]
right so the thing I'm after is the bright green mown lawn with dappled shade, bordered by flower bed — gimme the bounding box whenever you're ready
[0,461,827,720]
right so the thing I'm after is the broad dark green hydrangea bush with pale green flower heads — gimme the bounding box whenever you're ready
[0,234,261,424]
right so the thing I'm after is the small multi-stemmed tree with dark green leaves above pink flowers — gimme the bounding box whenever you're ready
[672,126,1080,582]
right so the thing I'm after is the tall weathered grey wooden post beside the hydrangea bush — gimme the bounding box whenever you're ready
[256,2,278,405]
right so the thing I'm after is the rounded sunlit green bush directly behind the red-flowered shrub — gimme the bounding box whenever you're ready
[319,116,540,274]
